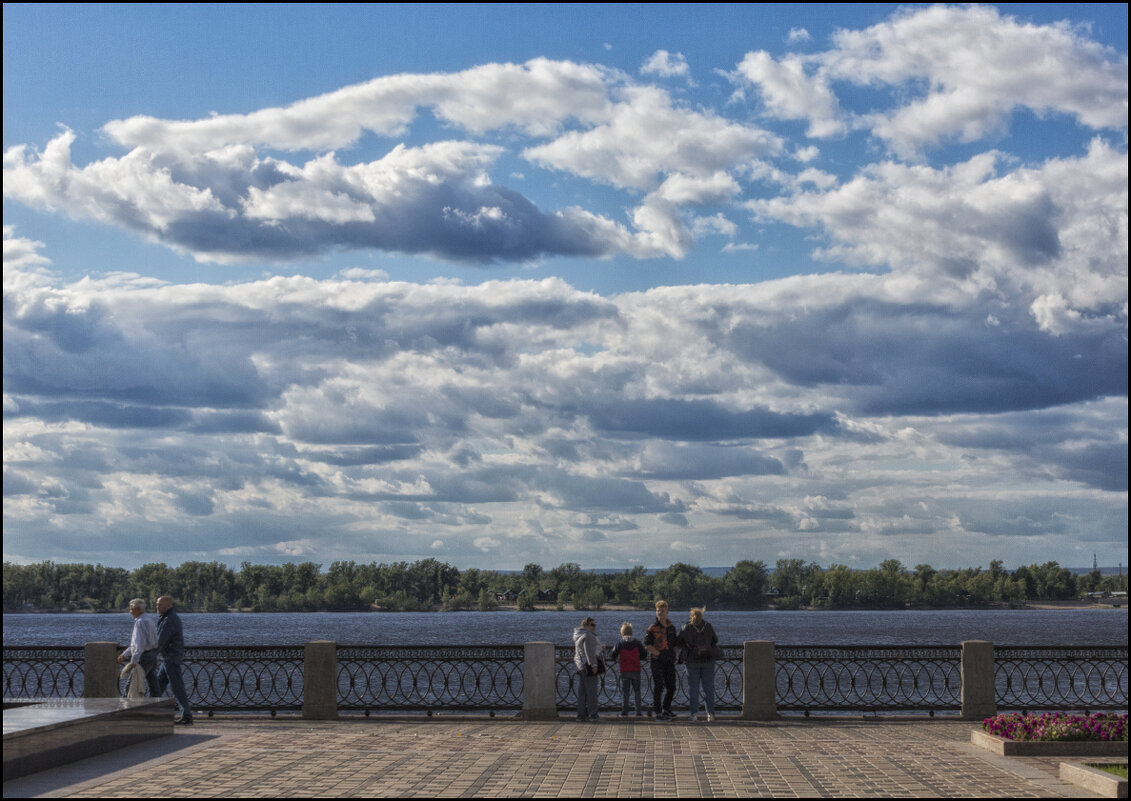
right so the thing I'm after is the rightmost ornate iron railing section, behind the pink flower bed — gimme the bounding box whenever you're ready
[994,645,1128,710]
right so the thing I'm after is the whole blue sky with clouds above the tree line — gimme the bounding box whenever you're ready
[3,3,1128,569]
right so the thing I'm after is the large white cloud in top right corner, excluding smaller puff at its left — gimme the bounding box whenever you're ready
[821,6,1128,157]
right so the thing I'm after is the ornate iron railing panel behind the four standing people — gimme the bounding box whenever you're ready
[554,645,742,712]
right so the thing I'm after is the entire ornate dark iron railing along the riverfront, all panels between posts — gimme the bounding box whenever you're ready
[3,645,1128,713]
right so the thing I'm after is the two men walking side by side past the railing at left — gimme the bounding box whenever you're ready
[118,595,192,726]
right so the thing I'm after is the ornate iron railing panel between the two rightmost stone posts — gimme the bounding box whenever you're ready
[774,645,962,713]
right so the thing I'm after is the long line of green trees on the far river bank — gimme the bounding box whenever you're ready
[3,559,1126,612]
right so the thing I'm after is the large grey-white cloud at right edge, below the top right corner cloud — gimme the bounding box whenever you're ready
[748,140,1128,333]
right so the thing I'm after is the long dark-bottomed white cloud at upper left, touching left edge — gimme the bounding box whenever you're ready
[5,131,636,262]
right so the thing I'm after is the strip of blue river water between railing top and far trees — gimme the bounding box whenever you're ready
[3,608,1128,646]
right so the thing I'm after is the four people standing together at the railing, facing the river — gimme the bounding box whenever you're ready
[573,601,720,723]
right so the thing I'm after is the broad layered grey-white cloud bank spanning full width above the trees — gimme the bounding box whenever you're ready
[5,246,1126,565]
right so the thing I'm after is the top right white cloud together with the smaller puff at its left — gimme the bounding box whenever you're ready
[734,6,1128,158]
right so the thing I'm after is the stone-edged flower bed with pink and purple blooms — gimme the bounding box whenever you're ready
[970,712,1128,757]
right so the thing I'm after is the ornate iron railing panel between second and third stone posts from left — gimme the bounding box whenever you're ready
[338,645,524,714]
